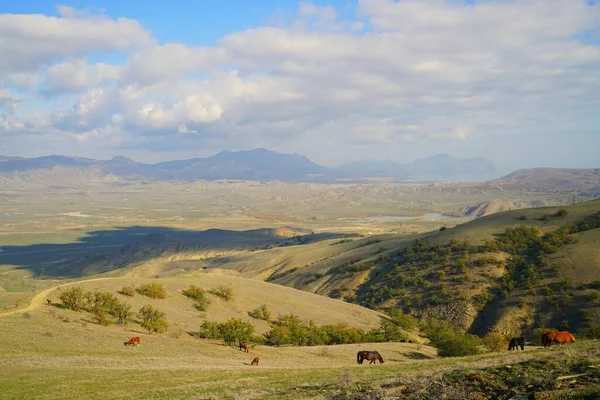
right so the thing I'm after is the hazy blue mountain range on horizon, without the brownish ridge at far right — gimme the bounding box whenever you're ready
[0,149,496,182]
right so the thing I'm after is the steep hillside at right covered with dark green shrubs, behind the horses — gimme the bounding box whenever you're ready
[329,200,600,335]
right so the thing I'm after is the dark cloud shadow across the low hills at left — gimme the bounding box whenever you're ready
[0,226,351,278]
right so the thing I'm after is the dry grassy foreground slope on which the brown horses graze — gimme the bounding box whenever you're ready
[0,306,600,399]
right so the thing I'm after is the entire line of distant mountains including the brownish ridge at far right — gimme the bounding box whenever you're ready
[0,149,600,190]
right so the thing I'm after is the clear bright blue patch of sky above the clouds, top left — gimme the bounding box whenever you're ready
[0,0,356,46]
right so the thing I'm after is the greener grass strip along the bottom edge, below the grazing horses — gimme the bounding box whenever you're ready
[0,341,600,399]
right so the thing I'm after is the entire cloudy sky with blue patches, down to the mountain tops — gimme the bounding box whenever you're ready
[0,0,600,168]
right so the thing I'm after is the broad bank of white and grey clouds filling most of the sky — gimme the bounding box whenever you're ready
[0,0,600,166]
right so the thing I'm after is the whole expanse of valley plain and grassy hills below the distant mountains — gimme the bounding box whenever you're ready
[0,168,600,399]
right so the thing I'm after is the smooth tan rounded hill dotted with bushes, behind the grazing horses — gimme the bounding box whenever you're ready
[32,271,394,333]
